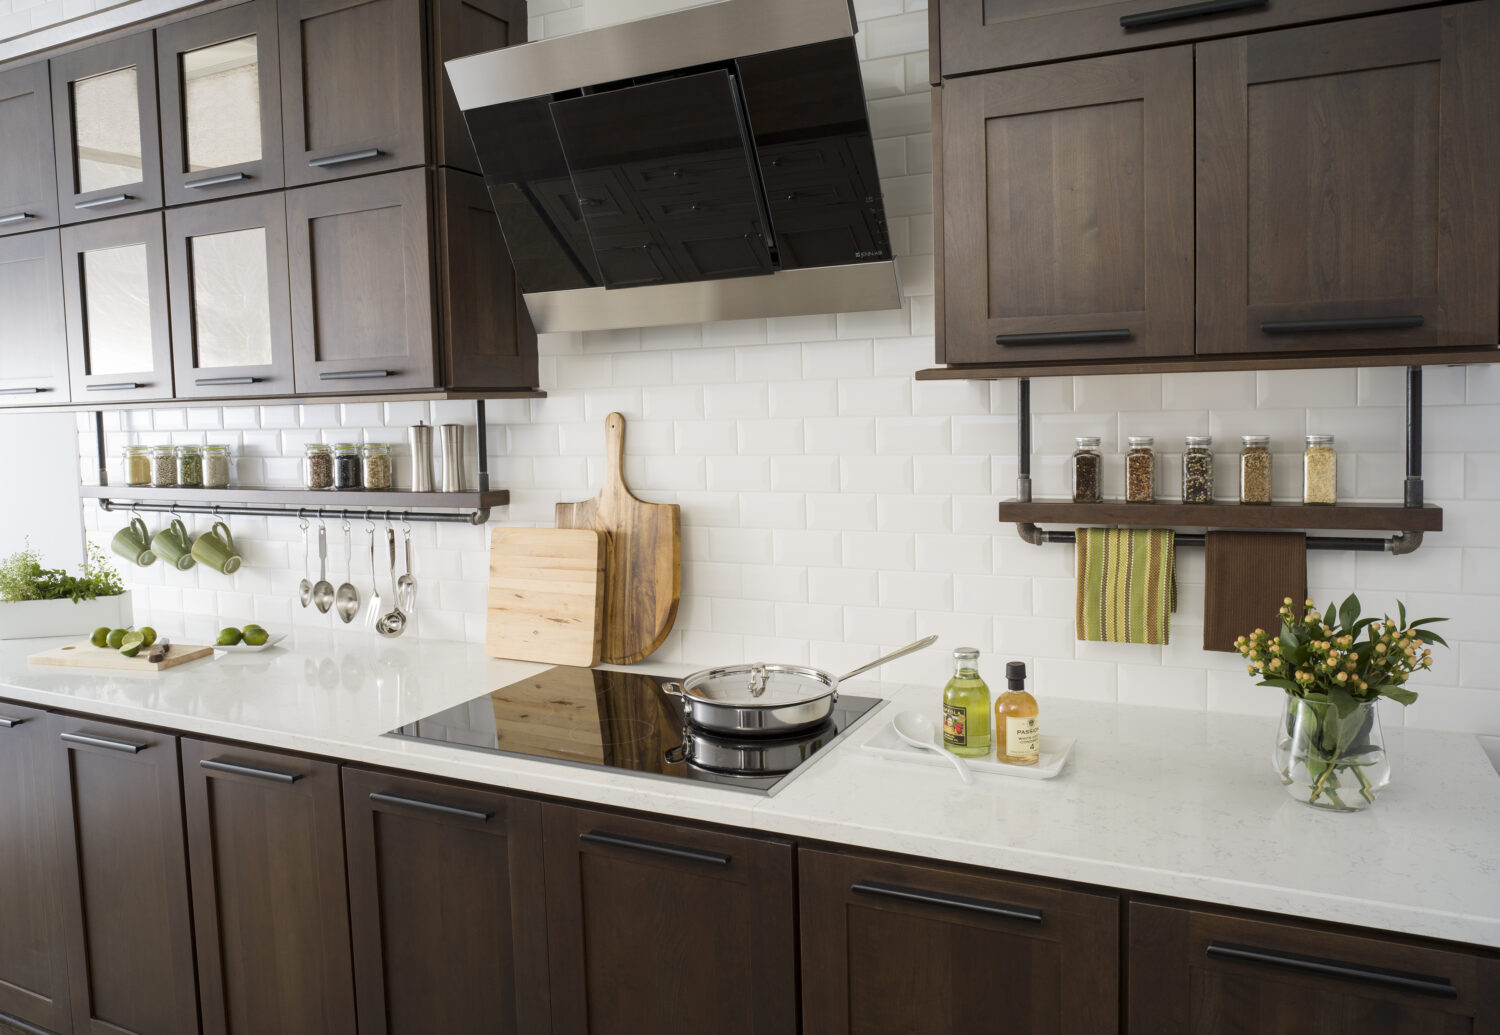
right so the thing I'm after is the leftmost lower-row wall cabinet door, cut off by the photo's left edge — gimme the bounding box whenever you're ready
[0,230,71,407]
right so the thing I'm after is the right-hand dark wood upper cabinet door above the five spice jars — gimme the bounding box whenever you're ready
[1197,3,1500,354]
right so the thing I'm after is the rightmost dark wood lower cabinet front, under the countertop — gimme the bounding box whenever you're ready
[1127,902,1500,1035]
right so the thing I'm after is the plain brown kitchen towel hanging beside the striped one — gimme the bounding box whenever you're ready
[1203,533,1308,651]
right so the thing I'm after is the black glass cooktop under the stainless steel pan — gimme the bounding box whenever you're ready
[387,666,881,794]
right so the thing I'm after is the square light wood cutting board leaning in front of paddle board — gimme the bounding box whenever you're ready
[485,528,605,668]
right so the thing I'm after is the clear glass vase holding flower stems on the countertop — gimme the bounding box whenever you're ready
[1274,693,1391,812]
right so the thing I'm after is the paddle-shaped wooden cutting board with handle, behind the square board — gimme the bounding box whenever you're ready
[557,414,683,665]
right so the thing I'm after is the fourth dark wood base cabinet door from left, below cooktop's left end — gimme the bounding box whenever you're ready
[342,767,551,1035]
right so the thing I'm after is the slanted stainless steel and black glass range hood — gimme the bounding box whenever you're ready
[447,0,900,332]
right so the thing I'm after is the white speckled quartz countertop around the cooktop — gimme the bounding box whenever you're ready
[0,630,1500,947]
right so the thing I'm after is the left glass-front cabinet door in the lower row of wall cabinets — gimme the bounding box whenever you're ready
[63,212,173,402]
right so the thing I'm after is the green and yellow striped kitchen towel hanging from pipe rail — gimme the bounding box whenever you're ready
[1077,528,1178,644]
